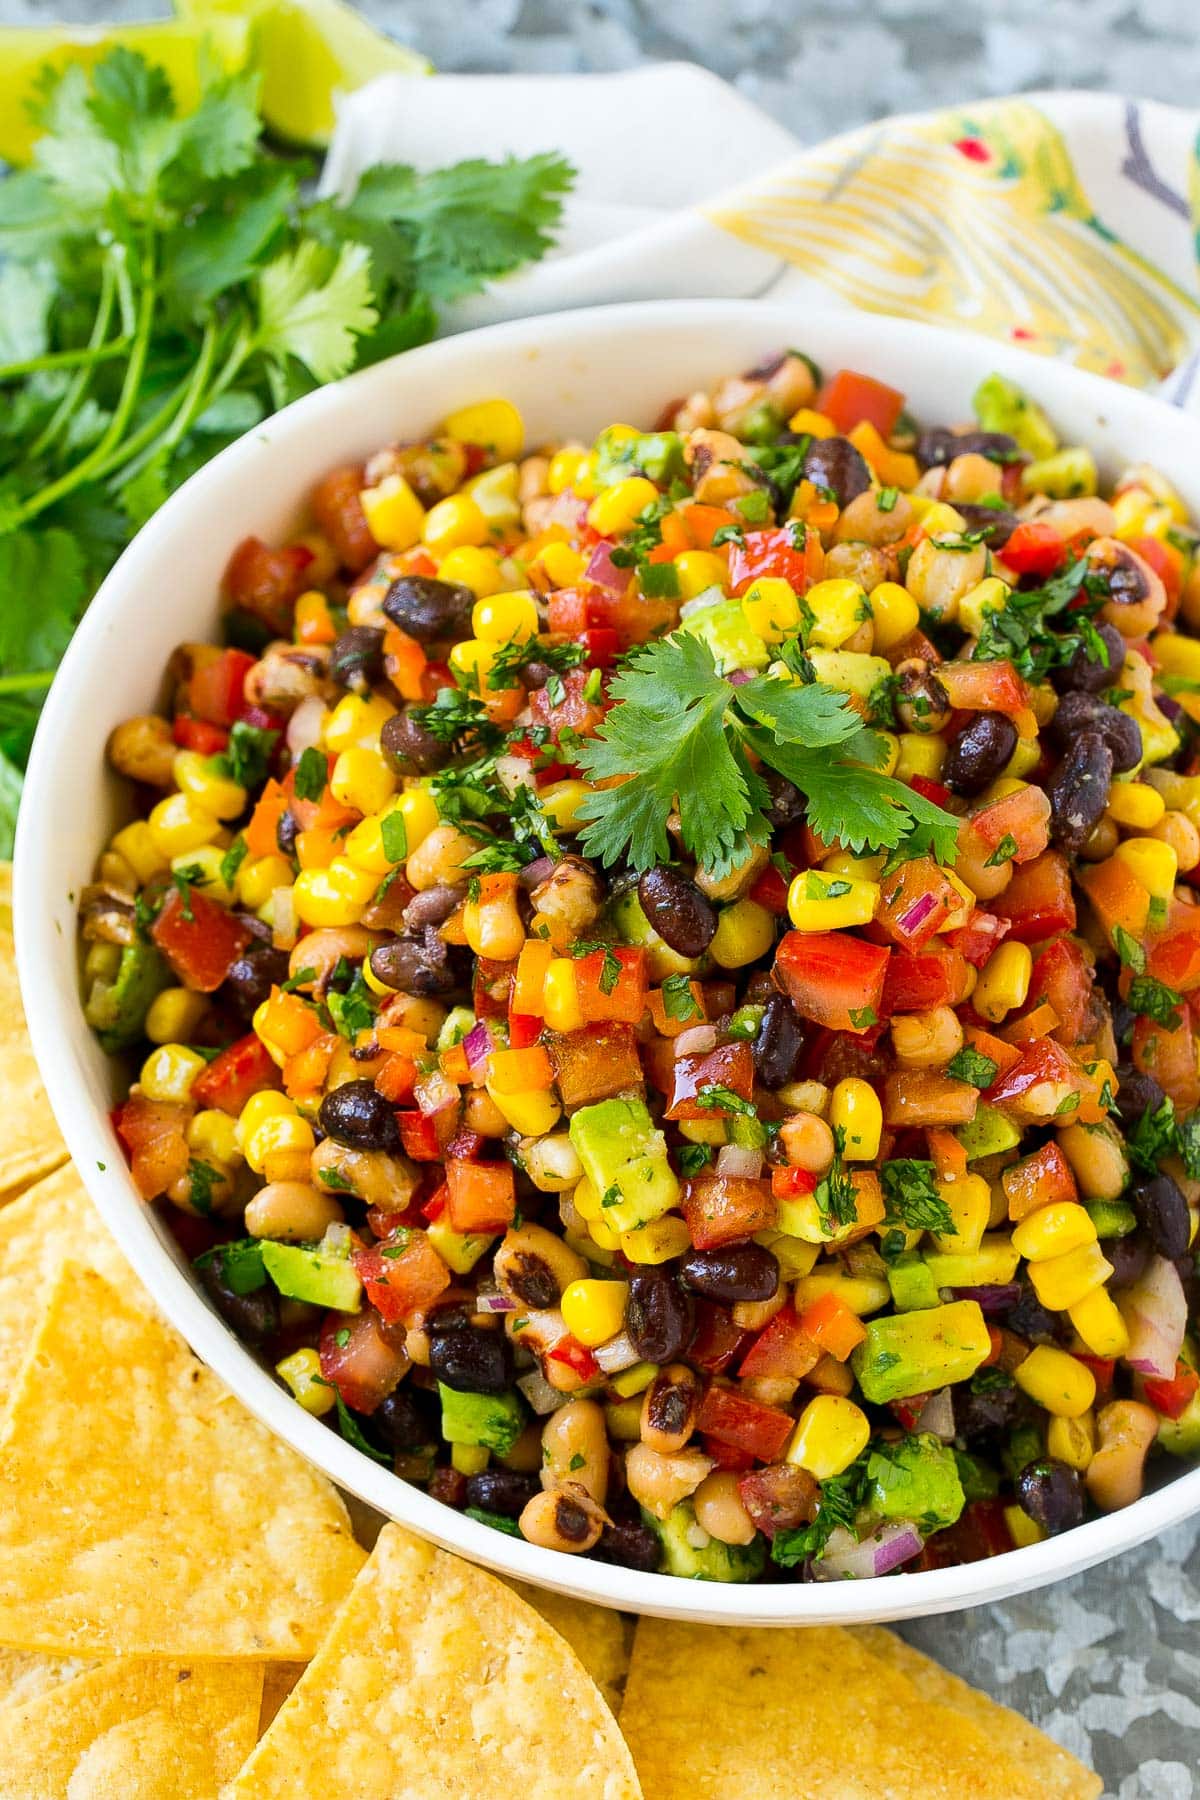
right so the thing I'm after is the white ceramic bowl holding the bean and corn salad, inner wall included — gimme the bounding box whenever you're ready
[16,301,1200,1625]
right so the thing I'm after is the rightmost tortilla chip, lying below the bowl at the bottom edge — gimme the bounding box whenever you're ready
[621,1618,1045,1800]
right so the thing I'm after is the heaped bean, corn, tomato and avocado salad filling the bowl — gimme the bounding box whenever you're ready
[81,353,1200,1580]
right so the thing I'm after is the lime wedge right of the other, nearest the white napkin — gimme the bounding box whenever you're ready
[176,0,430,148]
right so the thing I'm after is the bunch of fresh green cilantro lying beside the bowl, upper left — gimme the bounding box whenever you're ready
[0,49,570,853]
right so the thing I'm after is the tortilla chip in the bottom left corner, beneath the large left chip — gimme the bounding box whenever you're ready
[0,1658,263,1800]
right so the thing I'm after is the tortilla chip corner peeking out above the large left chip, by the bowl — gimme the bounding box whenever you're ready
[0,1163,149,1415]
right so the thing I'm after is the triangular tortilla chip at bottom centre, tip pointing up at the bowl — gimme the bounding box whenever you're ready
[228,1525,640,1800]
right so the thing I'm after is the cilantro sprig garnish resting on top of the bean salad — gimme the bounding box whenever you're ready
[578,632,959,880]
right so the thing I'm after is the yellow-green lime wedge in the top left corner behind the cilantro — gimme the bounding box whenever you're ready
[0,11,250,162]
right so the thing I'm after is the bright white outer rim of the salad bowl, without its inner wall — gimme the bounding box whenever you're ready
[13,301,1200,1625]
